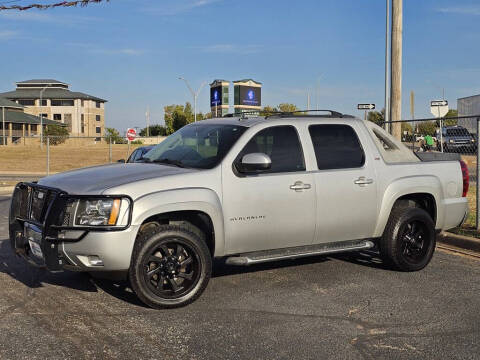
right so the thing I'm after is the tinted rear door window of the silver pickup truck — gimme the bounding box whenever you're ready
[308,125,365,170]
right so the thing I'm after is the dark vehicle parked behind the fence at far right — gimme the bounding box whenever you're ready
[437,125,477,153]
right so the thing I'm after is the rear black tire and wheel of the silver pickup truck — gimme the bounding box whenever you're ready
[379,207,436,271]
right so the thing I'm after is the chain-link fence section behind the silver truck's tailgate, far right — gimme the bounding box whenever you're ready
[384,115,480,237]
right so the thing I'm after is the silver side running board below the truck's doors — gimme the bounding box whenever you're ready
[226,240,375,266]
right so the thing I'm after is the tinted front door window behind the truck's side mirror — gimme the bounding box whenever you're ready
[237,126,305,173]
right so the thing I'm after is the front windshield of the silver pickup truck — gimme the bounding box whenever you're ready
[144,123,246,169]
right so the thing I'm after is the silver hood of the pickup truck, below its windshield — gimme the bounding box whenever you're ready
[38,163,199,195]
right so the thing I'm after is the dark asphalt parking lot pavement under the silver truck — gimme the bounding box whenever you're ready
[0,196,480,359]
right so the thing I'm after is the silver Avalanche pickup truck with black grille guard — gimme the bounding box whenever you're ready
[9,112,469,308]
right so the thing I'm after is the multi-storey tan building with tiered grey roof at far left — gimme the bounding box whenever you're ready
[0,79,106,137]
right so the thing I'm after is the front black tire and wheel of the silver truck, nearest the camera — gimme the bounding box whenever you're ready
[129,223,212,309]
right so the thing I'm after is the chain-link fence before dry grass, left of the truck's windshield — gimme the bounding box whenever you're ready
[0,136,164,177]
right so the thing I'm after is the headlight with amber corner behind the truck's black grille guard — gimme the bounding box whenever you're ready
[75,198,122,226]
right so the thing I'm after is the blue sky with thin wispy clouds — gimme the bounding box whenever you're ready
[0,0,480,130]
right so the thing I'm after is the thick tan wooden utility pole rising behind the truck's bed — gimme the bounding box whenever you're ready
[390,0,403,140]
